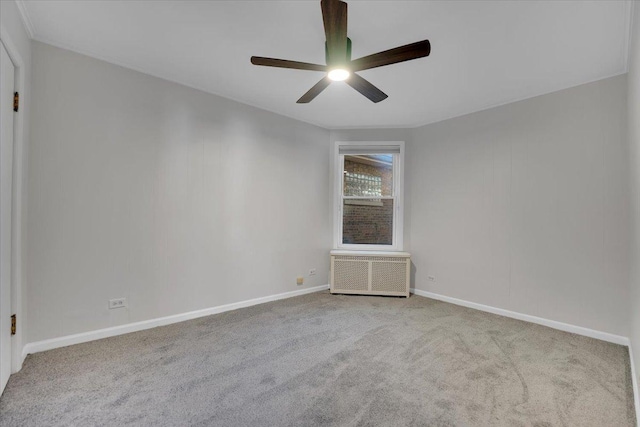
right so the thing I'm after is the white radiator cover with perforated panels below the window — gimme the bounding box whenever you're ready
[330,250,411,297]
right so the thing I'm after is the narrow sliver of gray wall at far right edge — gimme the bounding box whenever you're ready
[627,3,640,384]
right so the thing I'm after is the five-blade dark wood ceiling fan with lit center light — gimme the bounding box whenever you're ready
[251,0,431,104]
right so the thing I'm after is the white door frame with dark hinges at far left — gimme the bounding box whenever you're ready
[0,23,29,373]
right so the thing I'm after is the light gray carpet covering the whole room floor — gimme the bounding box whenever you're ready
[0,292,635,426]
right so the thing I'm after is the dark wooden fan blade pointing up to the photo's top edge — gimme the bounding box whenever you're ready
[320,0,347,65]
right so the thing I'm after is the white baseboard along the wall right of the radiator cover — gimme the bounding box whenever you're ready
[411,288,629,346]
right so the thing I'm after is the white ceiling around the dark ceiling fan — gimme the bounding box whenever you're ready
[18,0,631,128]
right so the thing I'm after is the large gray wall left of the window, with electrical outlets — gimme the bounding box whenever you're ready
[28,42,331,342]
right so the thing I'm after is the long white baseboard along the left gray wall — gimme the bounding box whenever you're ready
[22,285,329,360]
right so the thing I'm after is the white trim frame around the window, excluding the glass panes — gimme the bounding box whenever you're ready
[333,141,404,252]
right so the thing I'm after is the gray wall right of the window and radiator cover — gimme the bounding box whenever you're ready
[406,76,630,336]
